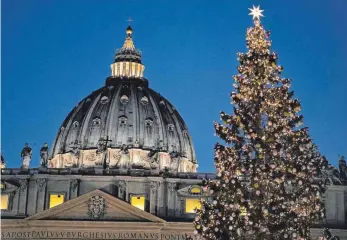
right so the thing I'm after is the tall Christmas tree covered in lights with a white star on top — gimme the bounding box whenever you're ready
[194,6,325,240]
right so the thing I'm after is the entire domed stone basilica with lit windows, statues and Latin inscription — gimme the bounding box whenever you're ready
[1,26,347,240]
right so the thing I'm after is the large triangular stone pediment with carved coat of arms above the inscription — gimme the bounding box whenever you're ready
[26,189,165,223]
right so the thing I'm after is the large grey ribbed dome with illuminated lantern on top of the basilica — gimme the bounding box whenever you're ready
[50,26,197,172]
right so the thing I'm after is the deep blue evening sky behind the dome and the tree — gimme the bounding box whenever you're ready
[1,0,347,172]
